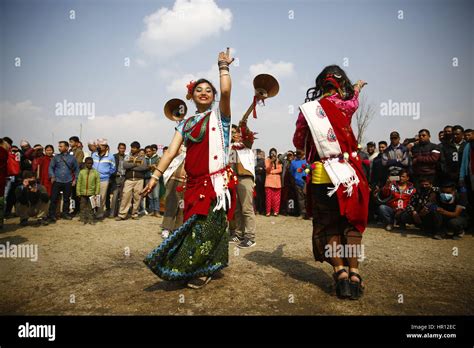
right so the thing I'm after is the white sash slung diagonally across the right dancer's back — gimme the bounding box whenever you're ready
[300,100,359,197]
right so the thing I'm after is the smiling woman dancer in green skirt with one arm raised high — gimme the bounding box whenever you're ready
[142,48,237,288]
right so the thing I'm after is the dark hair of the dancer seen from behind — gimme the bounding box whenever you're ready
[305,65,354,102]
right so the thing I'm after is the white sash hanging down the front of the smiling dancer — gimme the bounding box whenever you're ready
[209,110,230,211]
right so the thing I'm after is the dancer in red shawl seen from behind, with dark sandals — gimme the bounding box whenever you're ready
[293,65,369,300]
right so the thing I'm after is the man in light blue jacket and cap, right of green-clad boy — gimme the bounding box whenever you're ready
[92,139,115,219]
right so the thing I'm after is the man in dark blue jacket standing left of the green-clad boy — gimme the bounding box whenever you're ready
[48,141,79,222]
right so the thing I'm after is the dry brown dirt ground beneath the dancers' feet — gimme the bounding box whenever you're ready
[0,216,474,315]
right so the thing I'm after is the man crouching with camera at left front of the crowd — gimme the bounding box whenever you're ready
[15,171,49,226]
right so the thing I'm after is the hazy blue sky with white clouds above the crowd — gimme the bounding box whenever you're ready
[0,0,474,151]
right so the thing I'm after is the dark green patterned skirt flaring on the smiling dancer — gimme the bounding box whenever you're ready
[143,205,229,280]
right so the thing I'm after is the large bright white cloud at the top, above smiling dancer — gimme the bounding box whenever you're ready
[138,0,232,58]
